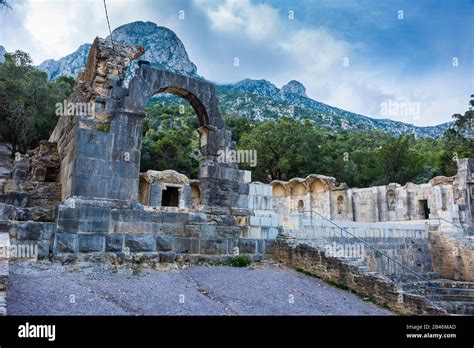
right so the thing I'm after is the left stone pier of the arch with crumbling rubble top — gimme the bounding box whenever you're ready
[50,38,144,199]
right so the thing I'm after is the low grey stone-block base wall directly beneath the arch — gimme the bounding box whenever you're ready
[53,197,265,257]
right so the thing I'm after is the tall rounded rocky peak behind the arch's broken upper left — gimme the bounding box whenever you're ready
[37,22,198,80]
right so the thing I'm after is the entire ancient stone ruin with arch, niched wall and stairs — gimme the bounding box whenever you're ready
[0,38,474,314]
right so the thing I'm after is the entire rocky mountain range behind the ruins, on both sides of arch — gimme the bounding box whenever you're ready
[35,22,450,137]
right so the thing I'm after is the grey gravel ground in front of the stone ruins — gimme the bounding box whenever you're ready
[7,264,392,315]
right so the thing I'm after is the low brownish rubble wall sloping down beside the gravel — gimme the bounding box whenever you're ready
[272,239,446,315]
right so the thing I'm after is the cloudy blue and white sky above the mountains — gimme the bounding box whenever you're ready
[0,0,474,126]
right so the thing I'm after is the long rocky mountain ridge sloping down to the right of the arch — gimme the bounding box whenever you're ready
[218,79,451,137]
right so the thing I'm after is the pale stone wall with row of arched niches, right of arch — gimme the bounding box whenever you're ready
[271,159,474,228]
